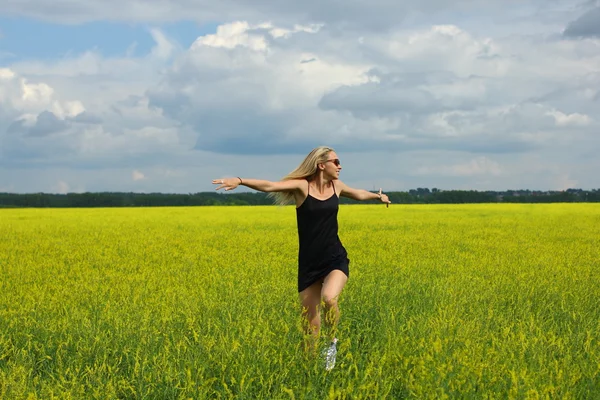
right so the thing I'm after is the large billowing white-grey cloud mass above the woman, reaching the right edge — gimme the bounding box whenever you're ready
[147,23,597,158]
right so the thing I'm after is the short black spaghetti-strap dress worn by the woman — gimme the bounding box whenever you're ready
[296,182,350,292]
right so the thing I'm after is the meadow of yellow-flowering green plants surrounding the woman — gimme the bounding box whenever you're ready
[0,204,600,399]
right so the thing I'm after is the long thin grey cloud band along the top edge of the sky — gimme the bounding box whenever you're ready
[3,0,560,31]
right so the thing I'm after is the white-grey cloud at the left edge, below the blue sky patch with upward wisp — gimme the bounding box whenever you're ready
[0,30,193,168]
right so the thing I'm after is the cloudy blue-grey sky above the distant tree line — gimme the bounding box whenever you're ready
[0,0,600,193]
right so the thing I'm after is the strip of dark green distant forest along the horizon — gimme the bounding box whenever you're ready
[0,188,600,208]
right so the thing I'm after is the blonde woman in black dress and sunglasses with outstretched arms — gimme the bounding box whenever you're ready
[212,146,390,370]
